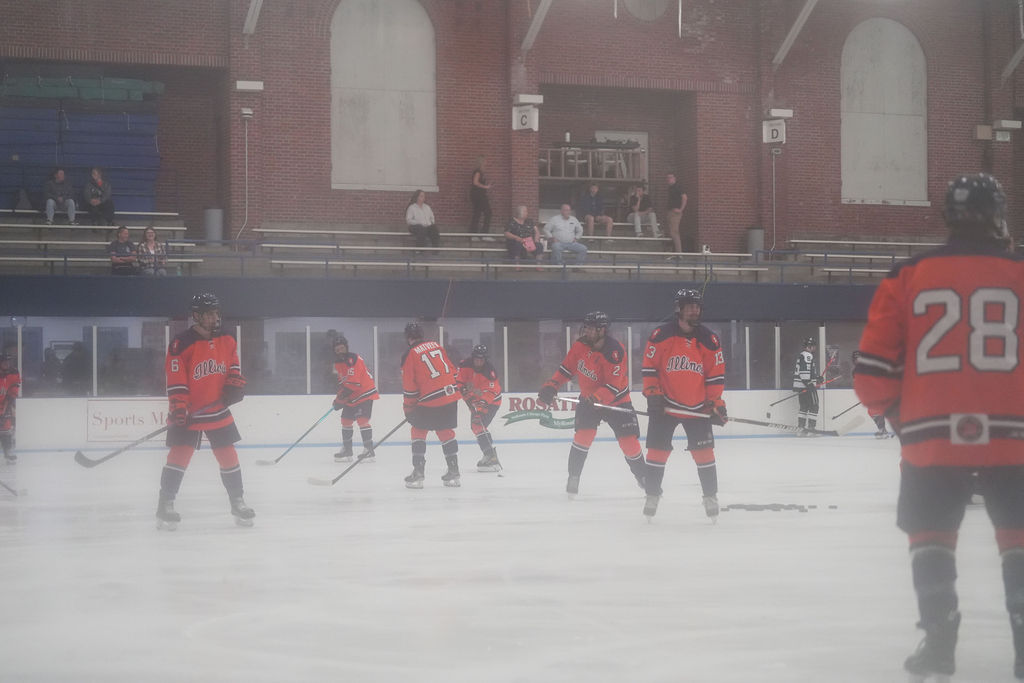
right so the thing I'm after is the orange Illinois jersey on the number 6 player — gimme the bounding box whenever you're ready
[165,328,245,431]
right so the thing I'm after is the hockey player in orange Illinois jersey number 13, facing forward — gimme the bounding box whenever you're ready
[642,290,728,519]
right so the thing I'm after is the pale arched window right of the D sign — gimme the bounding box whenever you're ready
[840,18,928,206]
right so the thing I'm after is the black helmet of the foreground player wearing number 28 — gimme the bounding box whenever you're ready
[944,173,1010,243]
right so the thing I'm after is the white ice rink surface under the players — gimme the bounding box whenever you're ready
[0,427,1013,683]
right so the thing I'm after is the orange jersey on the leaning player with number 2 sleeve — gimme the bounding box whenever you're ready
[548,335,630,405]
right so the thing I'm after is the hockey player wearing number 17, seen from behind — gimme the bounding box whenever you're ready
[401,323,462,488]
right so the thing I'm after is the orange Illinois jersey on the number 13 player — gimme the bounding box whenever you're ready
[641,321,725,411]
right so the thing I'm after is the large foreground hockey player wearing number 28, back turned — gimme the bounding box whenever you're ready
[854,173,1024,680]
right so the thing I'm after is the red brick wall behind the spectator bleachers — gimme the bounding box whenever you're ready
[6,0,1024,245]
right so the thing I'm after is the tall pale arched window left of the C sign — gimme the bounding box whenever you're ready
[331,0,437,191]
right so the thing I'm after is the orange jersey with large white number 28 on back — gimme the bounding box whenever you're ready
[854,240,1024,466]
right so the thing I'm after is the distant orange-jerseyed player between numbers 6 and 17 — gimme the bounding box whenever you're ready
[334,335,380,463]
